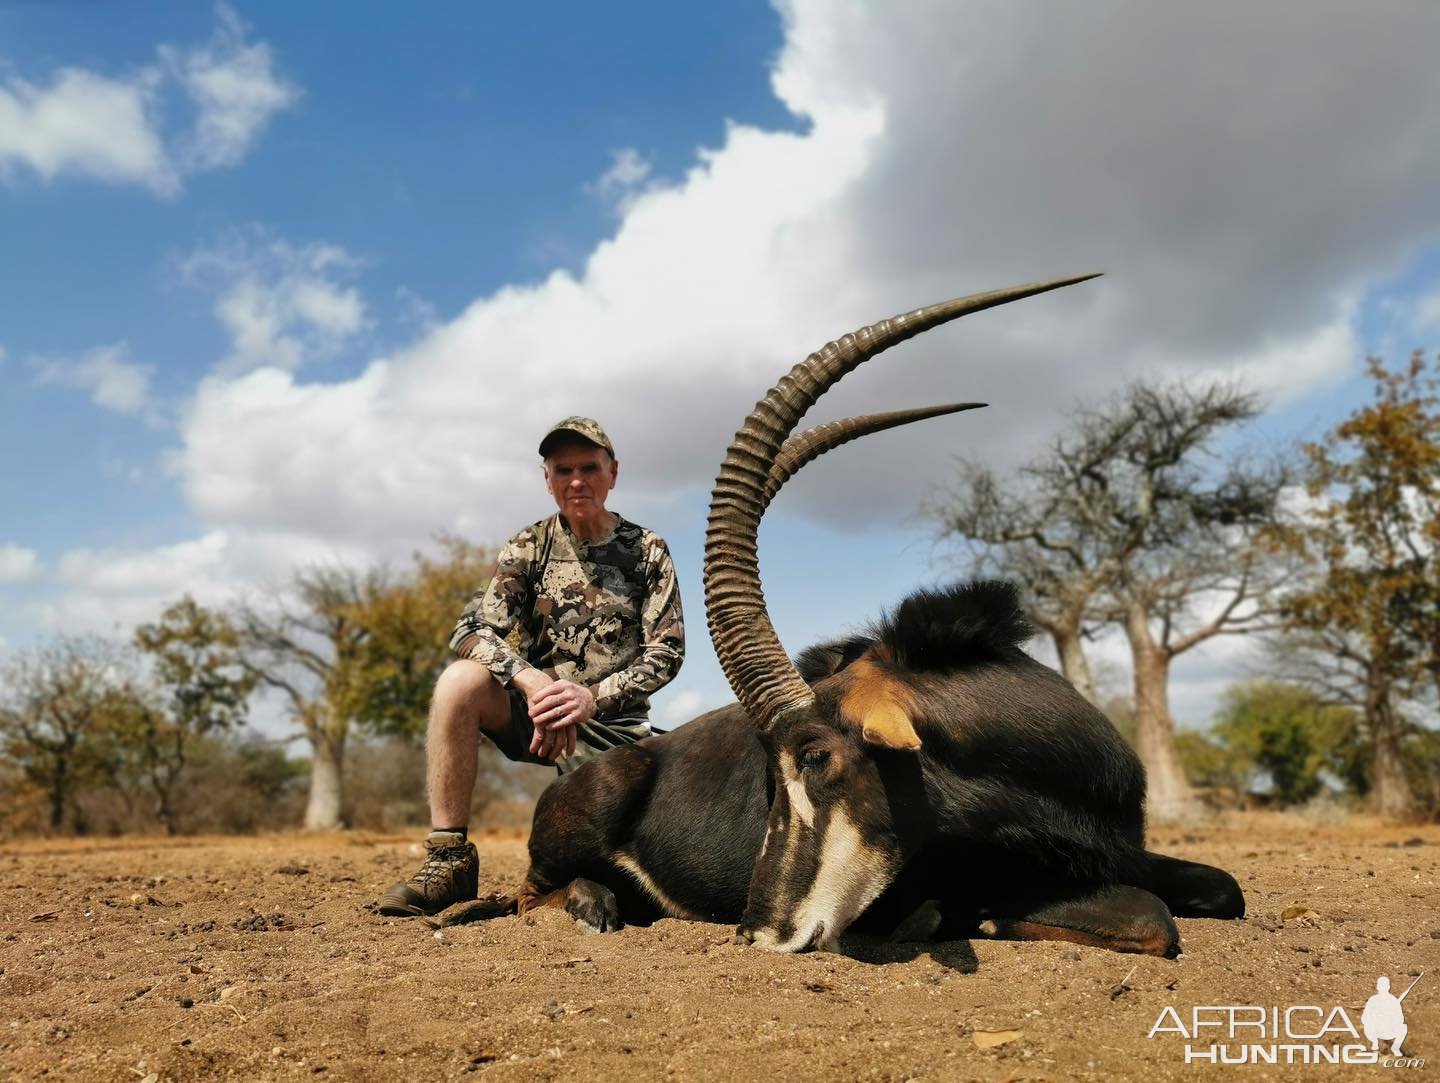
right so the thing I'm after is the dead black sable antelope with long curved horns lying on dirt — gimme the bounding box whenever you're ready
[492,275,1244,956]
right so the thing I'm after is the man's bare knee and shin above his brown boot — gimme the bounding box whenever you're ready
[425,658,510,828]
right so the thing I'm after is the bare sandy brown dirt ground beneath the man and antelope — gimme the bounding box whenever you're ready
[0,815,1440,1083]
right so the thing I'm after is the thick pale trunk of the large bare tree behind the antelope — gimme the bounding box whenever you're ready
[1125,602,1197,821]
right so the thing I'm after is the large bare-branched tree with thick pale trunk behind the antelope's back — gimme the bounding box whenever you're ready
[942,383,1287,815]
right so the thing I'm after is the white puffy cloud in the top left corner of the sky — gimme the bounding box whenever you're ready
[0,4,300,196]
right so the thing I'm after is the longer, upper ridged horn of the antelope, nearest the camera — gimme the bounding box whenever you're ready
[704,275,1096,730]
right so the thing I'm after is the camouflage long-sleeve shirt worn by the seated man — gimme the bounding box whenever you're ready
[451,516,685,722]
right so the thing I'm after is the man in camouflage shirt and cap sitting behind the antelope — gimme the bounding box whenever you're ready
[380,418,685,916]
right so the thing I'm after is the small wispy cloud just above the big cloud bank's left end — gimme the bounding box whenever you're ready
[181,229,367,374]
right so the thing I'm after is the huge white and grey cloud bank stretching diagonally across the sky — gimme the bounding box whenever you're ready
[33,0,1440,717]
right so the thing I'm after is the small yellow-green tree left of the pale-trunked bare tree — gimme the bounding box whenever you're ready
[124,595,258,835]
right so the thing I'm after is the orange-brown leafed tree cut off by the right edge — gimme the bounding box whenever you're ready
[1282,353,1440,818]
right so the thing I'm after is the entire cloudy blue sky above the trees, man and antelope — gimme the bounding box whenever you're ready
[0,0,1440,743]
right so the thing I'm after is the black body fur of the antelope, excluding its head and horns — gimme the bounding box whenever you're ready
[512,582,1244,952]
